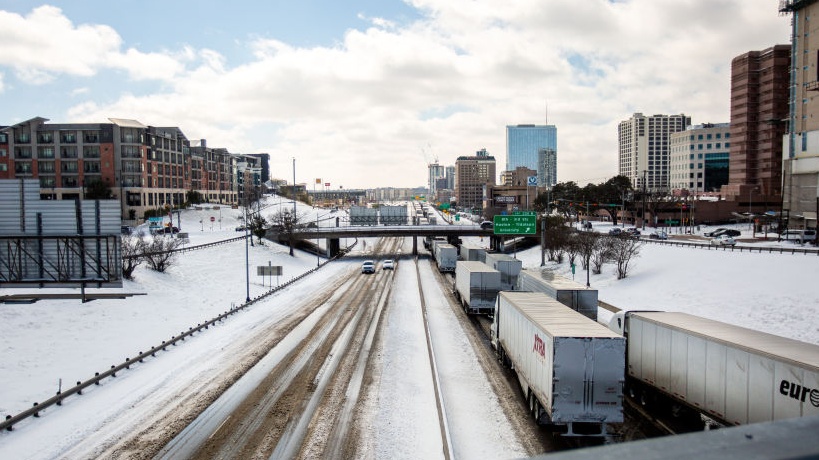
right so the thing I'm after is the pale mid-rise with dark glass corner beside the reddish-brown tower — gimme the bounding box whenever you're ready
[669,123,731,193]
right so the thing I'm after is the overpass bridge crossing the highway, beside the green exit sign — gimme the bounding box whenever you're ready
[267,225,510,257]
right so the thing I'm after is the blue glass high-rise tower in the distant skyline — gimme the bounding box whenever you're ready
[506,125,557,186]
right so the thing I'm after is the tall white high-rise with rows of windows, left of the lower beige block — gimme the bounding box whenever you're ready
[618,113,691,192]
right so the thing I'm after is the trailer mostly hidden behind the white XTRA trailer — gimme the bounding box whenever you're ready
[517,268,597,321]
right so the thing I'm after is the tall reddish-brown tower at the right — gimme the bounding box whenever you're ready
[721,45,792,202]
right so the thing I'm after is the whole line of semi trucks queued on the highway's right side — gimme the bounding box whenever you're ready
[436,241,819,437]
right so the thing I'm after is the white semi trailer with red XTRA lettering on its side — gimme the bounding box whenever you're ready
[491,291,626,438]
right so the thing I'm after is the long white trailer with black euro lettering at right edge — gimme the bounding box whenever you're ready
[610,311,819,425]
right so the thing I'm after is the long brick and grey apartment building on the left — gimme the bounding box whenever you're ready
[0,117,261,221]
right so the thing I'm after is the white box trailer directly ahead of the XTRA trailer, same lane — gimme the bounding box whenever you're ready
[455,260,500,314]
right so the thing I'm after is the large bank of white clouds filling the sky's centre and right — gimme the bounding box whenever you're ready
[52,0,789,187]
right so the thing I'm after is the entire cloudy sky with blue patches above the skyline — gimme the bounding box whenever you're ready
[0,0,790,189]
